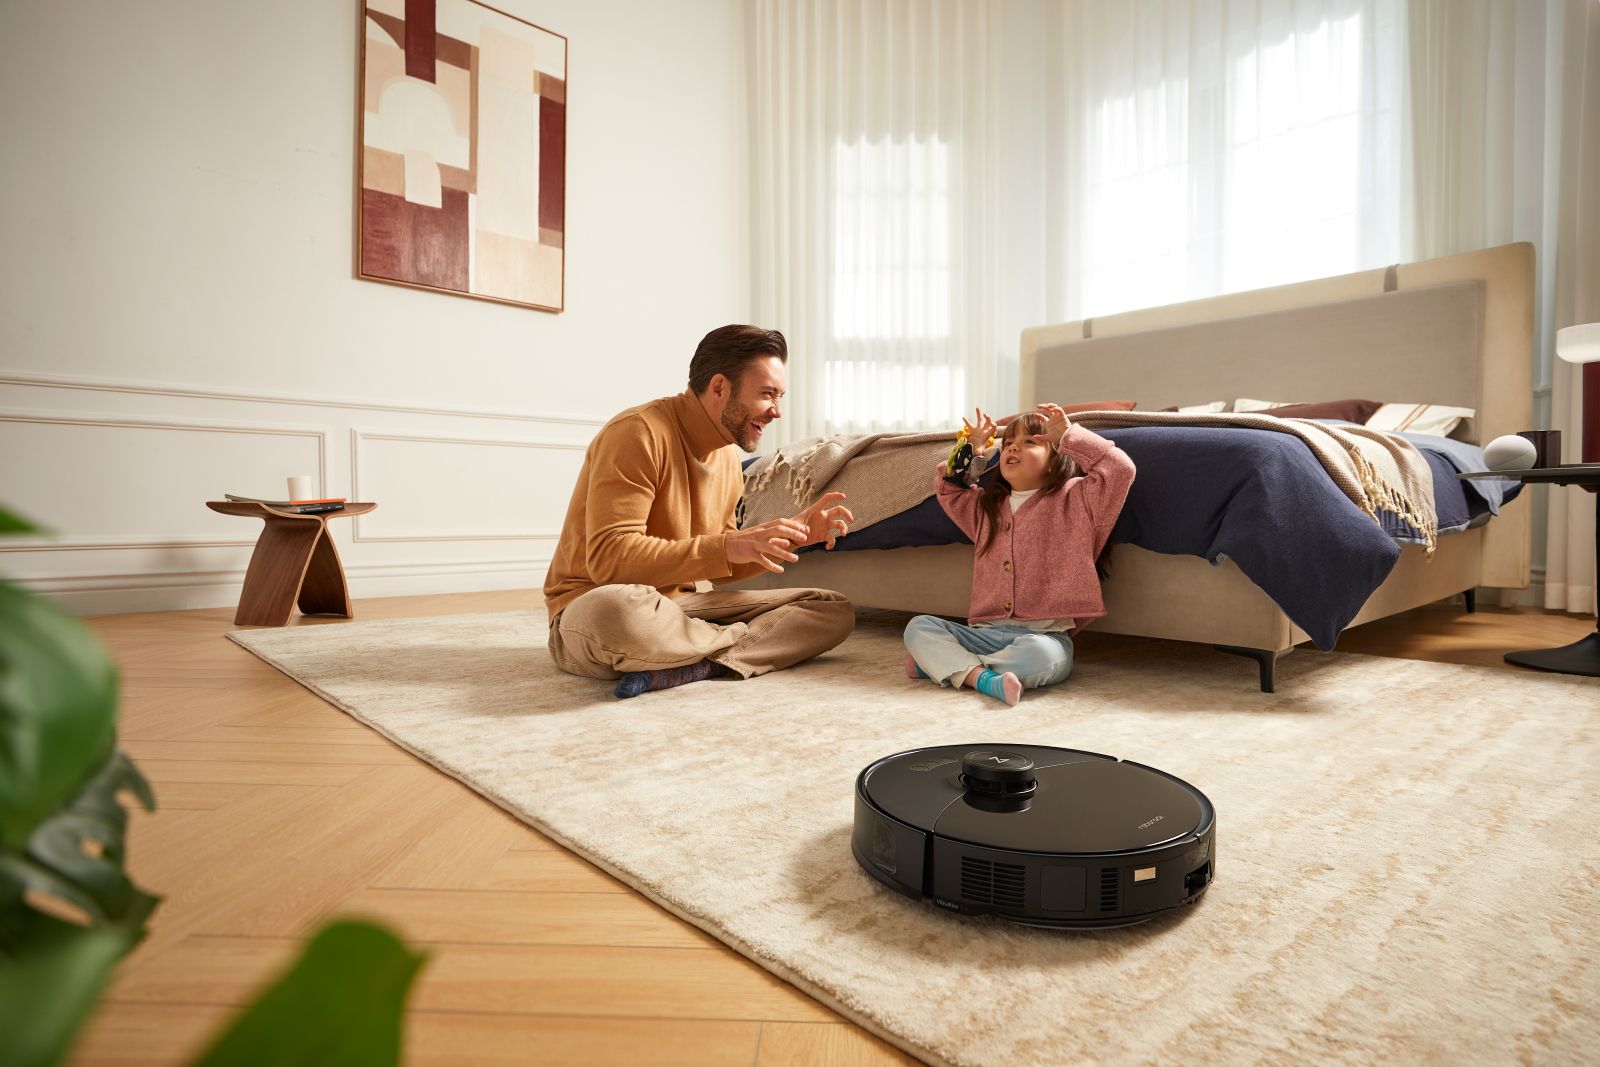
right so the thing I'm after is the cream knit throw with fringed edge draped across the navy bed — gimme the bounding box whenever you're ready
[744,411,1438,553]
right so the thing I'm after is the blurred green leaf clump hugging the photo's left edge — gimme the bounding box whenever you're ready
[0,521,157,1067]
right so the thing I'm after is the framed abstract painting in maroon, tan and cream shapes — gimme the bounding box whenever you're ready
[355,0,566,312]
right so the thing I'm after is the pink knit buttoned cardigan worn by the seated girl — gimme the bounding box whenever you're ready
[936,426,1134,632]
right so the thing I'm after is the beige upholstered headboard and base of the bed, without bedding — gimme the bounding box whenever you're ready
[741,243,1533,693]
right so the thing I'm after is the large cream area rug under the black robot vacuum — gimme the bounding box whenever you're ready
[230,613,1600,1065]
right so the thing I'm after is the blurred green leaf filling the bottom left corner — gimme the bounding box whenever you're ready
[0,917,133,1067]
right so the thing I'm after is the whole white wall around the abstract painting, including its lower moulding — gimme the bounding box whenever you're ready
[0,0,750,611]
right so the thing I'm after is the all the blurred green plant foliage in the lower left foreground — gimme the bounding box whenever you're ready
[0,509,424,1067]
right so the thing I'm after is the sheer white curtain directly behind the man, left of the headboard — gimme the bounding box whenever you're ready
[750,0,1014,443]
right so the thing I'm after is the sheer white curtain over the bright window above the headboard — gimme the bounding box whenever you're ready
[1046,0,1405,320]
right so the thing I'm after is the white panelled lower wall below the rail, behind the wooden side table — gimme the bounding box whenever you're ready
[0,371,605,617]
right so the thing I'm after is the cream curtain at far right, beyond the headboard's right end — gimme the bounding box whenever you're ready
[1405,0,1600,613]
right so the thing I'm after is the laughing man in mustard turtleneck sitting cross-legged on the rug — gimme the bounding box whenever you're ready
[544,326,856,697]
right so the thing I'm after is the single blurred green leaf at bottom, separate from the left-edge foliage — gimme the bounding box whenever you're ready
[197,921,427,1067]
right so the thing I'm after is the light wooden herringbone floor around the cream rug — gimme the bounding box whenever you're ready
[74,592,1594,1067]
